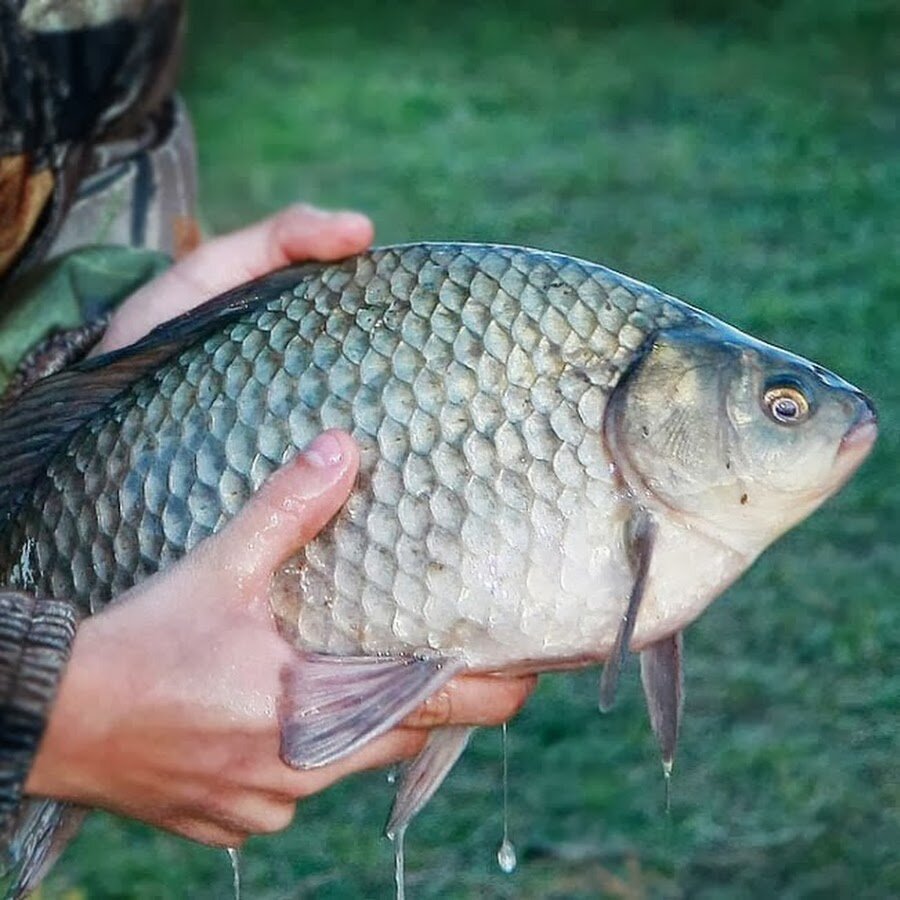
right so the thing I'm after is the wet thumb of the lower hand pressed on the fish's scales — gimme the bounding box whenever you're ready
[196,431,359,577]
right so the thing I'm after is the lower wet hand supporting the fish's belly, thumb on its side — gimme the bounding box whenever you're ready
[26,432,534,846]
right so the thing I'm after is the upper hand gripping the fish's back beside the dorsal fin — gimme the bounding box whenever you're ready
[100,204,374,353]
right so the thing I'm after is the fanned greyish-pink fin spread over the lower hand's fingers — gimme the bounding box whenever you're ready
[279,653,463,769]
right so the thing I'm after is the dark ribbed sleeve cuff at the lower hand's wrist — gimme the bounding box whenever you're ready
[0,590,77,842]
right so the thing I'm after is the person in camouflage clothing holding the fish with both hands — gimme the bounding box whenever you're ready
[0,0,534,892]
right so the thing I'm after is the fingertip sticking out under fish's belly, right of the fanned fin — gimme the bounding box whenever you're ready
[403,675,537,728]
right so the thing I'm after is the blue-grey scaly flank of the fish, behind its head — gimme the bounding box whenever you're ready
[5,245,681,652]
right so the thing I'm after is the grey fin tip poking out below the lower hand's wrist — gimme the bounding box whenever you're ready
[5,799,87,900]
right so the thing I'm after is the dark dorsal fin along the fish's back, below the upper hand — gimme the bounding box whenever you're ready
[0,269,297,522]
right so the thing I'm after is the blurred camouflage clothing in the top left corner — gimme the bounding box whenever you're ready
[0,0,195,288]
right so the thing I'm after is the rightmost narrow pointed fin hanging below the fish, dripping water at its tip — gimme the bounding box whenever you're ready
[641,631,684,775]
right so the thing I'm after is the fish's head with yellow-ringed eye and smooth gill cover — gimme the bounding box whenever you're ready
[604,319,877,560]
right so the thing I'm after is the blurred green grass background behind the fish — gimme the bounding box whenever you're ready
[44,0,900,900]
